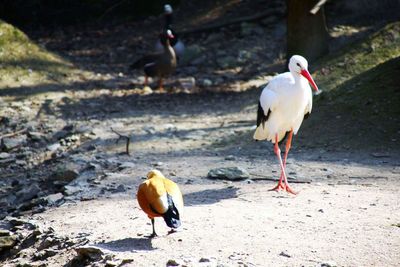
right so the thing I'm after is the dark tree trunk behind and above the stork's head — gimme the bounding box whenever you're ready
[287,0,329,60]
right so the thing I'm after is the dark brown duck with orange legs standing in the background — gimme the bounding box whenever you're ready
[130,30,176,91]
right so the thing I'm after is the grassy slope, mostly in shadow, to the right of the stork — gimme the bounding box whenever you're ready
[300,22,400,152]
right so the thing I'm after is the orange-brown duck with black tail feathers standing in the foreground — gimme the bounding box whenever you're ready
[137,170,183,237]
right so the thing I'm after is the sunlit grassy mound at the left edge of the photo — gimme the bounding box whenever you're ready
[0,20,76,89]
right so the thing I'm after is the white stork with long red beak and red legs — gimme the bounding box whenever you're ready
[253,55,318,194]
